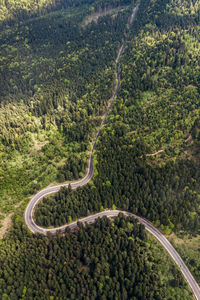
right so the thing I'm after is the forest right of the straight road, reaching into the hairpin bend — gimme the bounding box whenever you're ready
[35,1,200,233]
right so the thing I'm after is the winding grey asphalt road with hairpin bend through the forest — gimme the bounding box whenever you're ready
[25,6,200,300]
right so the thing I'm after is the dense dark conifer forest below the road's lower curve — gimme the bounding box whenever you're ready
[0,215,192,300]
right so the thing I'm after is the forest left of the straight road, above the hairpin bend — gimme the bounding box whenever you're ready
[0,1,134,218]
